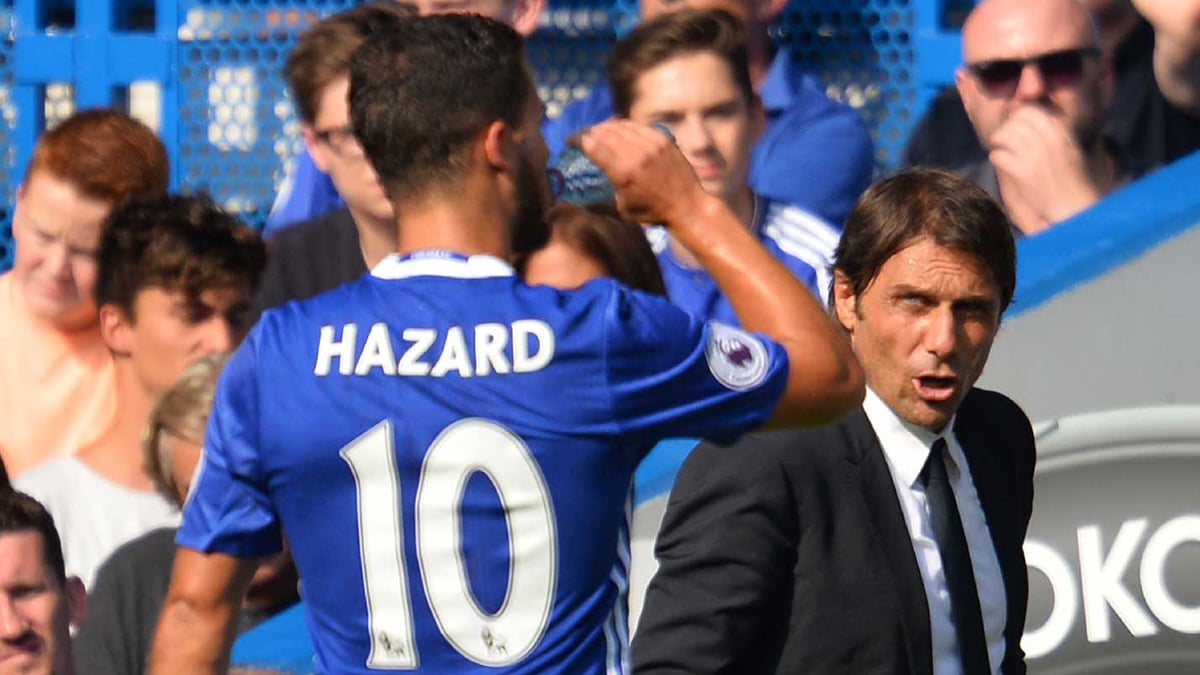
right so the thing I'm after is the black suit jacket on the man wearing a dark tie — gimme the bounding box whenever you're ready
[634,389,1034,675]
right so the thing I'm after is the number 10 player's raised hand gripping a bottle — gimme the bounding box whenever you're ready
[580,119,708,227]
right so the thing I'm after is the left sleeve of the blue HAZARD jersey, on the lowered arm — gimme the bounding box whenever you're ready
[175,330,282,557]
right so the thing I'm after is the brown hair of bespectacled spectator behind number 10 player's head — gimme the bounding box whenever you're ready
[283,0,416,124]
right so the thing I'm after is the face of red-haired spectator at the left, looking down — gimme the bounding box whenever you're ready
[12,171,112,330]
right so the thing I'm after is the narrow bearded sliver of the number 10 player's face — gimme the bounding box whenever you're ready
[512,85,554,252]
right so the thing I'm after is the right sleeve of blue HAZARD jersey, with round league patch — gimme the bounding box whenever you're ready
[605,288,787,443]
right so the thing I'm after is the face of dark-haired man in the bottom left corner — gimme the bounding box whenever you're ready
[0,530,83,675]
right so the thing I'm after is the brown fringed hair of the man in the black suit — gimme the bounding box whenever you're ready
[833,169,1016,312]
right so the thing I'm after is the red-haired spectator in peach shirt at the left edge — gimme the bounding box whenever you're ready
[0,110,169,478]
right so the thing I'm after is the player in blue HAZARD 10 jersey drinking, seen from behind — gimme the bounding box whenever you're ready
[151,16,863,675]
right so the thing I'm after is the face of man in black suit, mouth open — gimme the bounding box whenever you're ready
[834,238,1001,431]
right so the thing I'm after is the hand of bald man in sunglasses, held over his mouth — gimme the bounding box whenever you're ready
[989,106,1103,225]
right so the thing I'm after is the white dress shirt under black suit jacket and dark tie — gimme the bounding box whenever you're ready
[863,389,1008,675]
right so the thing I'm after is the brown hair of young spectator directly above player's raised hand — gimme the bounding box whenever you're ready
[608,10,755,118]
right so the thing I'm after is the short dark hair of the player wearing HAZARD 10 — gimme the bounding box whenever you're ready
[350,14,535,202]
